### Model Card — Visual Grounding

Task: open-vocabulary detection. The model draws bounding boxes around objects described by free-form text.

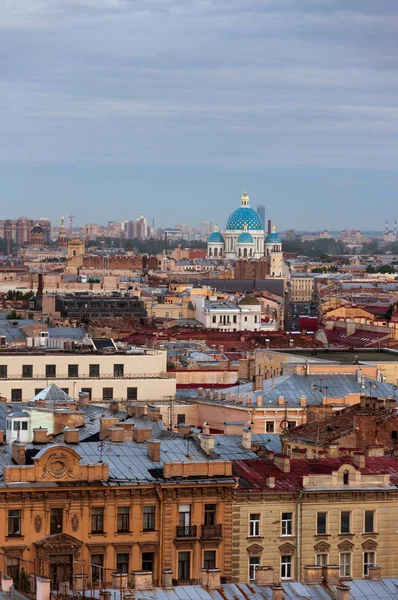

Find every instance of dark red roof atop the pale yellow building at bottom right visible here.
[233,457,398,493]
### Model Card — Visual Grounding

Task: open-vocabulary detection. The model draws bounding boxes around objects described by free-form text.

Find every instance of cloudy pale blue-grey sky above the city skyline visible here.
[0,0,398,230]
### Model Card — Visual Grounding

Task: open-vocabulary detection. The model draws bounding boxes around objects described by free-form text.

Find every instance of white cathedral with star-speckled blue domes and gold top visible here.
[207,192,283,277]
